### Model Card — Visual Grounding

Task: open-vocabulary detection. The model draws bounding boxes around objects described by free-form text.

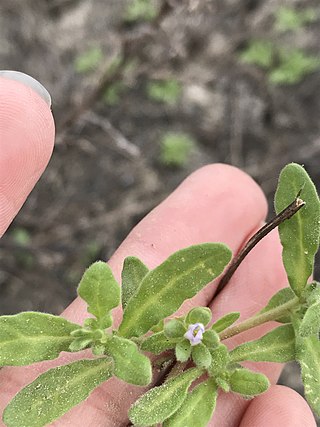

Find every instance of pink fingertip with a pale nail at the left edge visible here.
[0,71,54,237]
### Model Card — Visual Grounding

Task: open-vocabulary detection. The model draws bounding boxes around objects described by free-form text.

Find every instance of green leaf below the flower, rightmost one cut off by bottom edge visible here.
[163,378,217,427]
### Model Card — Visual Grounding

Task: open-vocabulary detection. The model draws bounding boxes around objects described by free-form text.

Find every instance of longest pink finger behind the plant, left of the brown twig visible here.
[0,165,266,427]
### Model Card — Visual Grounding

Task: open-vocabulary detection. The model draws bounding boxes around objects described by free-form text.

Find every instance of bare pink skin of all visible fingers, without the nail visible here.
[0,78,316,427]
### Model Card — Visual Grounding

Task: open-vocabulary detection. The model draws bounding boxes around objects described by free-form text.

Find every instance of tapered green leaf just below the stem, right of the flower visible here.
[230,324,295,363]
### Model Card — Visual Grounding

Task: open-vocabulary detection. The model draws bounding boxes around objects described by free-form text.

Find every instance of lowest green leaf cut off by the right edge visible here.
[295,322,320,416]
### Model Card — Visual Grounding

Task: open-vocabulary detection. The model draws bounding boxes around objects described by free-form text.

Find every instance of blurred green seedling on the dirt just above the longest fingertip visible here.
[160,132,196,168]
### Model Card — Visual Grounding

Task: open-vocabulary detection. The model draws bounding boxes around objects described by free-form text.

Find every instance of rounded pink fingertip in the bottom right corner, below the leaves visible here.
[239,385,316,427]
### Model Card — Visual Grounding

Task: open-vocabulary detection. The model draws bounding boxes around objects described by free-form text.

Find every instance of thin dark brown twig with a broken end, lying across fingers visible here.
[214,196,305,298]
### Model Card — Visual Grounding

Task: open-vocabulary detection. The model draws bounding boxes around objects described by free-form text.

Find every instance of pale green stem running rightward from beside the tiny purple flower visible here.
[219,297,300,341]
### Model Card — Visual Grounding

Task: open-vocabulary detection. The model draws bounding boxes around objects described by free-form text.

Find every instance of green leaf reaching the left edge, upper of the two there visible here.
[0,311,79,366]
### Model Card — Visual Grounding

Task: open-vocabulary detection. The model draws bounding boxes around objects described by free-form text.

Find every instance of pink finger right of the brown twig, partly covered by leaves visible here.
[211,230,287,427]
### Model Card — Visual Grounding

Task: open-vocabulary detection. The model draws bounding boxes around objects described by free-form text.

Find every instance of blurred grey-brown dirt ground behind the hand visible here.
[0,0,320,424]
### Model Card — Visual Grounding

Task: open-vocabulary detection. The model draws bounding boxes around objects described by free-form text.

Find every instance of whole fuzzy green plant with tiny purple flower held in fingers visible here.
[0,163,320,427]
